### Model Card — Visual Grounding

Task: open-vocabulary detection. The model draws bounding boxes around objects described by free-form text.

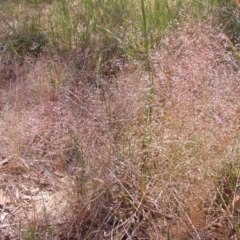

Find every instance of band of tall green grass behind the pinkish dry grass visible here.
[1,0,189,77]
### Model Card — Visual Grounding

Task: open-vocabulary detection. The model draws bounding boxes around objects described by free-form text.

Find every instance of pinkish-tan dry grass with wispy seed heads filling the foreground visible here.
[0,17,240,239]
